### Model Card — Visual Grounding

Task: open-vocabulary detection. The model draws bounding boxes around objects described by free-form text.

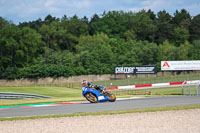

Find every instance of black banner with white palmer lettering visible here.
[115,66,156,74]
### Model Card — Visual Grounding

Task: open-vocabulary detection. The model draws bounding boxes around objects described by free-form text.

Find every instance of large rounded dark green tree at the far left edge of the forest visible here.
[0,25,43,79]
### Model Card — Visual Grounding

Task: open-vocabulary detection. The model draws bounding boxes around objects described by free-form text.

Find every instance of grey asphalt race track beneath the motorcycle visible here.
[0,96,200,118]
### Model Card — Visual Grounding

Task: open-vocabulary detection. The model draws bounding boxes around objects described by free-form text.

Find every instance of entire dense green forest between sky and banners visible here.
[0,9,200,79]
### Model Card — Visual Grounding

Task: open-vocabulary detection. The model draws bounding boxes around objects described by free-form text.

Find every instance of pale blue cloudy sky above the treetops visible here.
[0,0,200,24]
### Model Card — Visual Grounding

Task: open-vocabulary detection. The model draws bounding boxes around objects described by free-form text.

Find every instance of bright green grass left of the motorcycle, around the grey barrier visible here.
[0,86,85,106]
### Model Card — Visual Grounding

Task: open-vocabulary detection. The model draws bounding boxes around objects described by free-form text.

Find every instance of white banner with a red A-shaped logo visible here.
[161,60,200,71]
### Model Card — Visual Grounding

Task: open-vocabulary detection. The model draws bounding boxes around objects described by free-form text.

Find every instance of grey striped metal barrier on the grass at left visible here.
[0,92,51,100]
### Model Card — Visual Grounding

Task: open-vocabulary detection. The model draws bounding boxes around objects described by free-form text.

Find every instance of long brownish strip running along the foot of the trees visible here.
[0,71,200,87]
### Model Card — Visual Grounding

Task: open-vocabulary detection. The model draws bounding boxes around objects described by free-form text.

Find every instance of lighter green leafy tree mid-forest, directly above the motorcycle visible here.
[76,33,113,74]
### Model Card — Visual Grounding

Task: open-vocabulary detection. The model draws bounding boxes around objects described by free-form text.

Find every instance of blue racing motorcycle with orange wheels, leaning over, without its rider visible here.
[82,86,116,103]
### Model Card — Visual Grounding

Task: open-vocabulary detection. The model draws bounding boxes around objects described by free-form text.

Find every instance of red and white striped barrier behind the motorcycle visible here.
[107,80,200,90]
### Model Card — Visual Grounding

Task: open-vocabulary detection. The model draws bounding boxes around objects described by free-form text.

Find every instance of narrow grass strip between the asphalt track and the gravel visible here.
[0,105,200,121]
